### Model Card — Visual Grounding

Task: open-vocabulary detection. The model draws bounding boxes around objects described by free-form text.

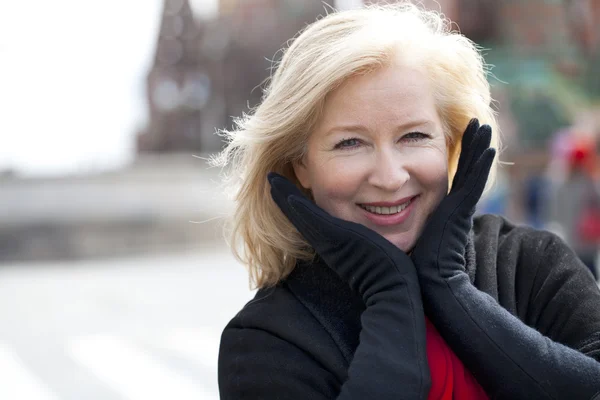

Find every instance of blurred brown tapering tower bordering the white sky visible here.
[138,0,211,151]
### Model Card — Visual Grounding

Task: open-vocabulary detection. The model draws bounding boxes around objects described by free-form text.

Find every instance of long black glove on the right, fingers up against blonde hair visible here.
[411,120,600,399]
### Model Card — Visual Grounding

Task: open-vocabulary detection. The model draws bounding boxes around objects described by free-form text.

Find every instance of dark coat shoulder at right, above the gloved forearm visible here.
[473,215,600,359]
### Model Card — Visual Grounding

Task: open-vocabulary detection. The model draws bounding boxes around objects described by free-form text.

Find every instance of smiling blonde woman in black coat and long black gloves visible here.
[215,4,600,399]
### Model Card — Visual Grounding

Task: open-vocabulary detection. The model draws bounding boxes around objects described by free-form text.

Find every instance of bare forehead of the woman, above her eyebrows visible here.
[322,65,439,130]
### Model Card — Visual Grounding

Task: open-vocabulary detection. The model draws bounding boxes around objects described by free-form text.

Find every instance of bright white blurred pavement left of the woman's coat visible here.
[0,245,253,400]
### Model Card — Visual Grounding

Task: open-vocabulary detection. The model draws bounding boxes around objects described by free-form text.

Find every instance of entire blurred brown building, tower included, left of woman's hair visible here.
[138,0,324,152]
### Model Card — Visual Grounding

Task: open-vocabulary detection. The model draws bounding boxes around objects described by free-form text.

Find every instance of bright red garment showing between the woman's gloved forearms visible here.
[425,318,488,400]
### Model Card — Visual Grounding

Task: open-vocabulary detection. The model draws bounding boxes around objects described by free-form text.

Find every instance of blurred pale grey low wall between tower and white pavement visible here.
[0,154,230,261]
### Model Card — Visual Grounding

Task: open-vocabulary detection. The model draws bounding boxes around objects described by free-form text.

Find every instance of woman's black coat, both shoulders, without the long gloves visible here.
[219,215,600,400]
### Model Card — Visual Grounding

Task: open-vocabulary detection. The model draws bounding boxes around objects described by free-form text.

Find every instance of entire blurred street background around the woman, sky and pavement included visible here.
[0,0,600,400]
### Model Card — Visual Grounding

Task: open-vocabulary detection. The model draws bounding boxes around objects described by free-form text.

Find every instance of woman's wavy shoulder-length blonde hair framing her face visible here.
[212,3,500,288]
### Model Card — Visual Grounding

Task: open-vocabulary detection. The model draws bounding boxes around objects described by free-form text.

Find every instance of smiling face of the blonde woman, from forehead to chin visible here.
[294,65,448,252]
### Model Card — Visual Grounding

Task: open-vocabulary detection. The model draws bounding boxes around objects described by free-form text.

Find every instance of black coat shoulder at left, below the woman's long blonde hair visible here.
[218,285,347,399]
